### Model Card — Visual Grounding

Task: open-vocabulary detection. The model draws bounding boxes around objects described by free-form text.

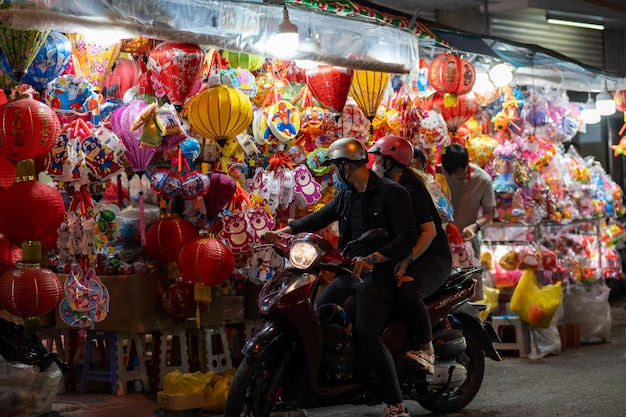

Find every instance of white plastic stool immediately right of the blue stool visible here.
[116,333,150,394]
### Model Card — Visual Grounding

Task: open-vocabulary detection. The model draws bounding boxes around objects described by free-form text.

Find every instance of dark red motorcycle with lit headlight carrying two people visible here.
[224,229,501,417]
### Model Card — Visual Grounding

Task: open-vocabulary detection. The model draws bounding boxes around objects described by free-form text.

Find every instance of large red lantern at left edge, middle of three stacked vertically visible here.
[0,159,65,245]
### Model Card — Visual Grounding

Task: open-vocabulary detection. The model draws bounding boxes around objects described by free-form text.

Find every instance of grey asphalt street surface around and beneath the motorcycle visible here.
[46,303,626,417]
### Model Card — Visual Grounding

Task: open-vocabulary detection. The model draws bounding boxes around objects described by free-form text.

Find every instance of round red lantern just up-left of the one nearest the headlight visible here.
[145,215,198,265]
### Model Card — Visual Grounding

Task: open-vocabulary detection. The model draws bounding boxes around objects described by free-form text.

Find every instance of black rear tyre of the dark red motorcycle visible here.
[417,325,485,413]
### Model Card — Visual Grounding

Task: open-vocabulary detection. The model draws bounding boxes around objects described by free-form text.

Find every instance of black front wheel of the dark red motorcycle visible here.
[224,349,287,417]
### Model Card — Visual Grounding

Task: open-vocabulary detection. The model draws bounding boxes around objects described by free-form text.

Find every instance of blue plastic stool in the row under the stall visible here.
[81,330,118,395]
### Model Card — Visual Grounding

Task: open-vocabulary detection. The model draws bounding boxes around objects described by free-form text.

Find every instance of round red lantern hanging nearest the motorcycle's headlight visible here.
[178,236,235,285]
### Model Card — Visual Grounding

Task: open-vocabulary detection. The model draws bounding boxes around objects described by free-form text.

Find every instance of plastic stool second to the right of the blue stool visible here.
[153,326,189,389]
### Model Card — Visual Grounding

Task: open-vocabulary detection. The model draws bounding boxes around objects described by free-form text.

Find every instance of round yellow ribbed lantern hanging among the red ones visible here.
[187,85,252,144]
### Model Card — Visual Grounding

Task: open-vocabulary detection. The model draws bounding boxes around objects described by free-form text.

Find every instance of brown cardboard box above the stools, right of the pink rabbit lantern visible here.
[55,273,173,333]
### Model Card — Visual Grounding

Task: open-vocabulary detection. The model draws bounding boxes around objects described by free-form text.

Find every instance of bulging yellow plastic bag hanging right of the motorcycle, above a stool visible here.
[511,269,563,328]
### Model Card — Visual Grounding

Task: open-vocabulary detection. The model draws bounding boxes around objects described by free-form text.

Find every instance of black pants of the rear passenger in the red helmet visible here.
[395,256,452,346]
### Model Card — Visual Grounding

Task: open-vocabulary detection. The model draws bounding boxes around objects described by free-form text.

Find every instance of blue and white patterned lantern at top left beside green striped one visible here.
[22,30,72,89]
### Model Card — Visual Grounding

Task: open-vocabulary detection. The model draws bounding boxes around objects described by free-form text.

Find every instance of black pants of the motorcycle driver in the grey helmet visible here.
[316,274,402,404]
